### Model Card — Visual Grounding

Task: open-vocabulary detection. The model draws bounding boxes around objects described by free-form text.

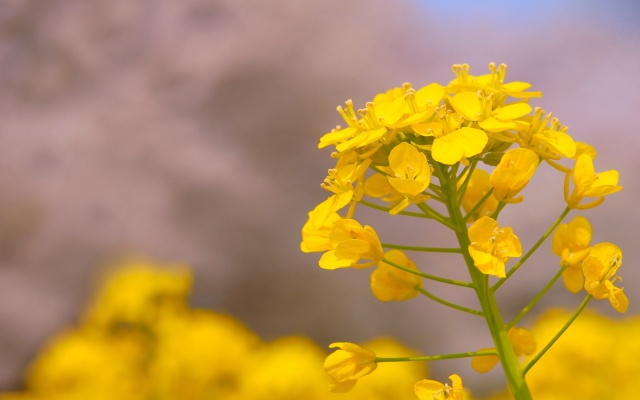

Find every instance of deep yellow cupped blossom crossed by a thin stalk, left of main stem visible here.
[371,250,422,301]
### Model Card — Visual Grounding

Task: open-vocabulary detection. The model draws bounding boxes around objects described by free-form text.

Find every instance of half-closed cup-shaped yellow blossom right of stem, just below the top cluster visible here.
[490,148,539,203]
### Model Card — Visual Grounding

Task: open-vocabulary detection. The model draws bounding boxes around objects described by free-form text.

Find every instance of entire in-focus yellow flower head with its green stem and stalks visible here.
[300,63,628,400]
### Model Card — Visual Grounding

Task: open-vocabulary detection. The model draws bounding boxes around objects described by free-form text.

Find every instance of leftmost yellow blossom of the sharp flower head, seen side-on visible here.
[300,192,353,253]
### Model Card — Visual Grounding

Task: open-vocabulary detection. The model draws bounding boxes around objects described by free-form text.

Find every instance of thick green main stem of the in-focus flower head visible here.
[434,163,533,400]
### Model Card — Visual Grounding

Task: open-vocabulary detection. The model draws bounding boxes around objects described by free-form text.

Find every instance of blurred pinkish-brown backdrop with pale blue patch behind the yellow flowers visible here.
[0,0,640,394]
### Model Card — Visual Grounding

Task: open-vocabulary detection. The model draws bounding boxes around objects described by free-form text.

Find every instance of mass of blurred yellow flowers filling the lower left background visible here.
[0,260,428,400]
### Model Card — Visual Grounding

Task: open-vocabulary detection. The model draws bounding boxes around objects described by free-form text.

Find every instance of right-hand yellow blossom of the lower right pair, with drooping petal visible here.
[582,243,629,313]
